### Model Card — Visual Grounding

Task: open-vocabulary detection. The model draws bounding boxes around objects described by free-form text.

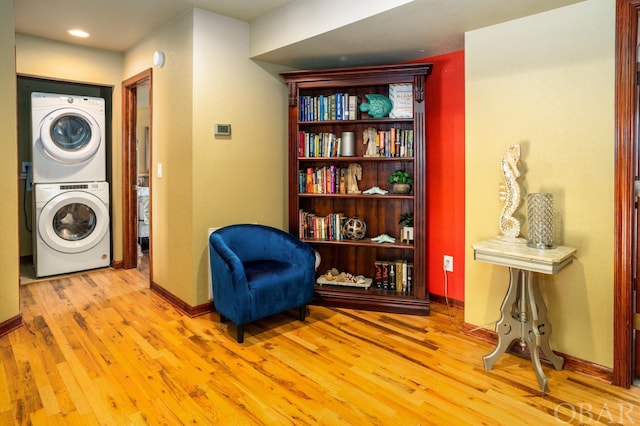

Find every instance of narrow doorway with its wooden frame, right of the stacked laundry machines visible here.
[122,69,153,282]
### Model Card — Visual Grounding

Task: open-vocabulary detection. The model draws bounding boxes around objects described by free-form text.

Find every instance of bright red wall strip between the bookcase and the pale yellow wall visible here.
[417,51,466,301]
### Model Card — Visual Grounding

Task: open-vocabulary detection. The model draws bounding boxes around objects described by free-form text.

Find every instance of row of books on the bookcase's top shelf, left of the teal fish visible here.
[298,93,358,121]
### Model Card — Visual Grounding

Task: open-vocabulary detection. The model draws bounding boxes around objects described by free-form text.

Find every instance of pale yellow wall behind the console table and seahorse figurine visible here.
[465,0,615,367]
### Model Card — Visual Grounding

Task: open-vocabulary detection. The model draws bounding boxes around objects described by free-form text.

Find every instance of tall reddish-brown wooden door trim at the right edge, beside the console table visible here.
[612,0,640,388]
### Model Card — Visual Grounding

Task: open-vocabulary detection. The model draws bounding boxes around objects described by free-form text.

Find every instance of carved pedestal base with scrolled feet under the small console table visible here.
[482,268,564,392]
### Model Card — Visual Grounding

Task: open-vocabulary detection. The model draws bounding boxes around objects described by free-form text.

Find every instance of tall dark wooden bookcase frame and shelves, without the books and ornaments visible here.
[281,64,432,315]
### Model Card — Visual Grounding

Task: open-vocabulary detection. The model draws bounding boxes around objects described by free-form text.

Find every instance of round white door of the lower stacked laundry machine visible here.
[38,191,109,253]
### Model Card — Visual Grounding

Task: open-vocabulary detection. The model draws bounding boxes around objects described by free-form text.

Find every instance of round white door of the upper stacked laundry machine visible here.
[40,108,102,164]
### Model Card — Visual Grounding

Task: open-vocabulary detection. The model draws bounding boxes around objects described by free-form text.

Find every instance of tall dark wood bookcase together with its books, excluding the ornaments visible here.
[281,64,431,315]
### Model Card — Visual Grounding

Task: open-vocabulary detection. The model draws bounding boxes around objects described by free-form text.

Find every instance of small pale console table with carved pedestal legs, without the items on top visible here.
[472,238,576,392]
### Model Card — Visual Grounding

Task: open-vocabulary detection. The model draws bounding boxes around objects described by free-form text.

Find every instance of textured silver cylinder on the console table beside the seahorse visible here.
[527,192,553,249]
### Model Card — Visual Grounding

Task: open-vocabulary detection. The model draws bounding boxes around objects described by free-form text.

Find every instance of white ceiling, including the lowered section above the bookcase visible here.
[14,0,583,69]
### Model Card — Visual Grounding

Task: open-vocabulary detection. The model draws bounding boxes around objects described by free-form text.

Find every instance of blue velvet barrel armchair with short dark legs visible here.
[209,224,315,343]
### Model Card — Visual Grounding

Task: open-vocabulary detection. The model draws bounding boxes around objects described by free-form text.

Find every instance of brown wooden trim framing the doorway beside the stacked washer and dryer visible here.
[122,68,153,272]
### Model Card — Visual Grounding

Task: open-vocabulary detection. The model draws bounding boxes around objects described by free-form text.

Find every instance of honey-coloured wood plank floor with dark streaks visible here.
[0,270,640,426]
